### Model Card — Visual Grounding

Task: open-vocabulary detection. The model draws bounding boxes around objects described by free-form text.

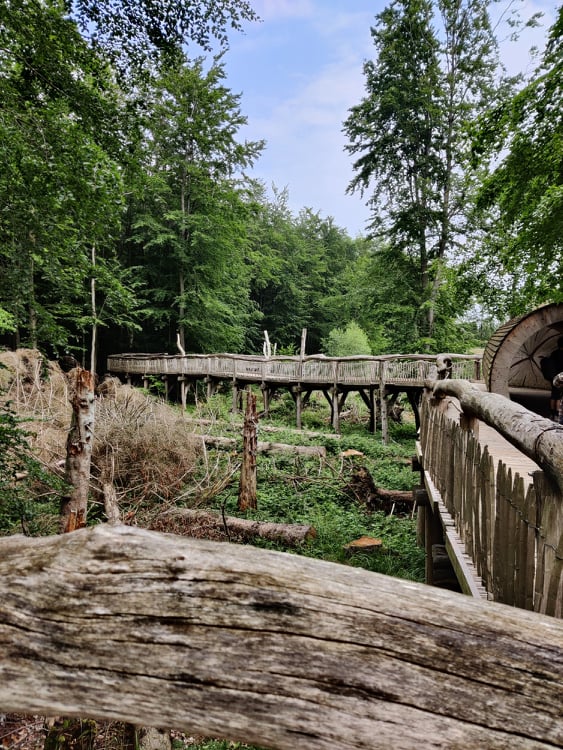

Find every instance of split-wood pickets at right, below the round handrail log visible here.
[420,399,563,617]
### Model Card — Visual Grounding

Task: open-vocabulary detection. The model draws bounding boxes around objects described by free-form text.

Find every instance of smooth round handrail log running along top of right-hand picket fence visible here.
[432,380,563,492]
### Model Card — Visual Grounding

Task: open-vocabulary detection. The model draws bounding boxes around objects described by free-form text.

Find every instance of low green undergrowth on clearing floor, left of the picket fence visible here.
[207,390,424,580]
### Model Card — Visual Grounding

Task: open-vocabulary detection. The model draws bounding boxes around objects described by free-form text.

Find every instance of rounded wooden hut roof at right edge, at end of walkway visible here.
[483,303,563,397]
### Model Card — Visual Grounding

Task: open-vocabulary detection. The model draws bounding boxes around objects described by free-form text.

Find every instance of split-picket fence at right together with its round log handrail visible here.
[420,381,563,617]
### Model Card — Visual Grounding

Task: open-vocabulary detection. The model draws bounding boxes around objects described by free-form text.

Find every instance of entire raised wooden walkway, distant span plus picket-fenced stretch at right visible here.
[108,354,563,617]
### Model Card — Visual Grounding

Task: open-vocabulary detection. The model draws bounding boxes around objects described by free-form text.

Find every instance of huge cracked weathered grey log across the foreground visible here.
[0,525,563,750]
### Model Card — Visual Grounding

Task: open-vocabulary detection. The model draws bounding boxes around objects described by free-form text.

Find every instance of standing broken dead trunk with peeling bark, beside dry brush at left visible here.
[60,367,95,533]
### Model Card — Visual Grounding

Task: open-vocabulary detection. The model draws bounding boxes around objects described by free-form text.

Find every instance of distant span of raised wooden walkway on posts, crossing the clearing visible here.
[107,354,481,440]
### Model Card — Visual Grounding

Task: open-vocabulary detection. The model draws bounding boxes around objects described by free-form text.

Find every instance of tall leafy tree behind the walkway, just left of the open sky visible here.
[133,59,262,351]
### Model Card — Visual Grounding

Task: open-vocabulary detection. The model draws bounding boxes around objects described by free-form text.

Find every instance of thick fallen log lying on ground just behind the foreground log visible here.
[152,508,317,546]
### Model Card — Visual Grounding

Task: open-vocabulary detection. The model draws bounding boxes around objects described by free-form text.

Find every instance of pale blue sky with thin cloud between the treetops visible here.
[214,0,557,237]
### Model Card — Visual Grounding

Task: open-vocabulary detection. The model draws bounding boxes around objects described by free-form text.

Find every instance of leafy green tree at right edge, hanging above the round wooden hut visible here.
[472,8,563,316]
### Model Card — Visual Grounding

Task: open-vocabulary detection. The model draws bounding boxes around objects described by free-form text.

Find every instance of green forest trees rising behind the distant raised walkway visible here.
[0,0,563,371]
